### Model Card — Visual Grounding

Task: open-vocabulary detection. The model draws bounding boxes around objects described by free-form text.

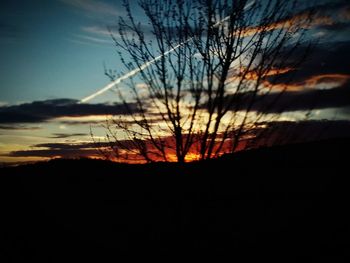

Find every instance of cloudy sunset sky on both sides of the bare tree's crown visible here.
[0,0,350,163]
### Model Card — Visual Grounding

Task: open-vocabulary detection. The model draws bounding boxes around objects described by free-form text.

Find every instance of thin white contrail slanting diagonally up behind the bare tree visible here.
[78,0,255,103]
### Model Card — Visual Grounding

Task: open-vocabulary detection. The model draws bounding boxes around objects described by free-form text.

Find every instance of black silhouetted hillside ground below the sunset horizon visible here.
[0,139,350,262]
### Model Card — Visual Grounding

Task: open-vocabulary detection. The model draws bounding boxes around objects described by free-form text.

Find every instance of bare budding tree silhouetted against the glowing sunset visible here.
[99,0,312,162]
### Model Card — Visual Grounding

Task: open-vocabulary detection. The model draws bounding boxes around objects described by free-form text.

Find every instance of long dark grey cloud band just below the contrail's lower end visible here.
[0,99,136,123]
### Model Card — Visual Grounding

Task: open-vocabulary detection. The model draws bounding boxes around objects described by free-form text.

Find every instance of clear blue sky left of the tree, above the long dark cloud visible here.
[0,0,129,104]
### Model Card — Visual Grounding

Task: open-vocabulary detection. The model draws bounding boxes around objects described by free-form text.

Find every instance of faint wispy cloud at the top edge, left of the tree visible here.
[61,0,122,16]
